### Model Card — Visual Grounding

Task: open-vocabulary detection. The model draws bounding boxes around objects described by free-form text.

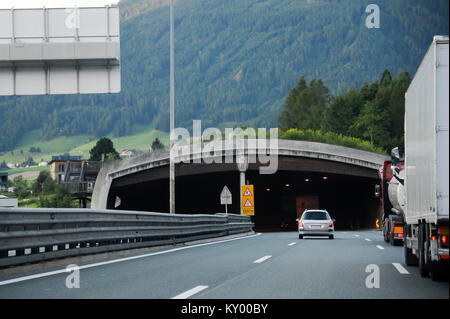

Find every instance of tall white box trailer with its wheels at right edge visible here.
[404,36,449,280]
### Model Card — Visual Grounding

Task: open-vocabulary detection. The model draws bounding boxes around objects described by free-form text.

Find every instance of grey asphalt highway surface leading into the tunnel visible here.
[0,231,449,299]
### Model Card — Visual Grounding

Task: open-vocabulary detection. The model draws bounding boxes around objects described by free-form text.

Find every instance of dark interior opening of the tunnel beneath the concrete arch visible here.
[108,168,381,231]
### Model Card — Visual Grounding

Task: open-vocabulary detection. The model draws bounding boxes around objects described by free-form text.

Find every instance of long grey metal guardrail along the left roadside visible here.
[0,208,254,267]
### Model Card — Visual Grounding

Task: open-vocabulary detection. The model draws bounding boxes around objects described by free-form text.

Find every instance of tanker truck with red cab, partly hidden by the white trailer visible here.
[375,156,405,246]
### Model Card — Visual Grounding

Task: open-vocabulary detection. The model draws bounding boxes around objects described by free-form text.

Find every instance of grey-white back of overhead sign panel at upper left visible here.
[0,0,121,96]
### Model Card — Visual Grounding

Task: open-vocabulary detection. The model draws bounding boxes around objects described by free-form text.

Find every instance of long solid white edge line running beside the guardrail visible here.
[0,233,261,286]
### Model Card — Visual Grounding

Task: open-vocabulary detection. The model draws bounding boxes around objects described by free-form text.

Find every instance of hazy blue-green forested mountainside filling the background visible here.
[0,0,449,152]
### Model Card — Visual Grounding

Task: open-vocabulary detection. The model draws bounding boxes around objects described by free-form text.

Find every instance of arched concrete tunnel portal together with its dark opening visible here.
[92,140,388,230]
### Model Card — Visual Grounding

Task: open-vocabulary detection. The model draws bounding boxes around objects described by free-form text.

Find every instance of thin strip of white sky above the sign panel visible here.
[0,0,120,9]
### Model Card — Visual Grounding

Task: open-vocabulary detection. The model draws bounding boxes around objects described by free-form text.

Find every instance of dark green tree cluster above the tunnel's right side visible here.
[278,70,411,152]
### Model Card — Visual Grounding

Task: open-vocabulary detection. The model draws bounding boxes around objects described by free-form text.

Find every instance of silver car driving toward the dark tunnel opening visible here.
[298,209,335,239]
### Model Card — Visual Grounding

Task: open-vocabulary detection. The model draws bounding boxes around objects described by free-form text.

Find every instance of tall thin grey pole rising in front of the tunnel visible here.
[169,0,175,214]
